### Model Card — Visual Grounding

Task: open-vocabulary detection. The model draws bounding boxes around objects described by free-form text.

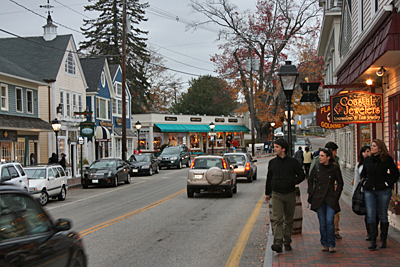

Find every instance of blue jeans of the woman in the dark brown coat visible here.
[317,200,336,247]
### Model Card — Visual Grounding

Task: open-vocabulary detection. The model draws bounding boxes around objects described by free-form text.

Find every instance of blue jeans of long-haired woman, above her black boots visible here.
[364,188,392,223]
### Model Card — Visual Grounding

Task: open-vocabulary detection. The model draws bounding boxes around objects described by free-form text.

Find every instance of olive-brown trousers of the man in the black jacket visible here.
[271,191,296,245]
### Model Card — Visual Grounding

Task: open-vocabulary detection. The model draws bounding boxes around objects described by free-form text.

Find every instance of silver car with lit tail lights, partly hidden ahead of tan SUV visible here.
[224,153,257,183]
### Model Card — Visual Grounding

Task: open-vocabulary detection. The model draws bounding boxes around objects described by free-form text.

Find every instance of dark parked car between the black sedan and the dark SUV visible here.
[128,153,160,176]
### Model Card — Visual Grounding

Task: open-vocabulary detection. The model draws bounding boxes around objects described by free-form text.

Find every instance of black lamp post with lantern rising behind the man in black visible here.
[278,61,299,156]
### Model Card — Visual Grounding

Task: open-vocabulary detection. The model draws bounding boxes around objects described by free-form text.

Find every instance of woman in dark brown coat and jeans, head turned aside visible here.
[308,148,343,252]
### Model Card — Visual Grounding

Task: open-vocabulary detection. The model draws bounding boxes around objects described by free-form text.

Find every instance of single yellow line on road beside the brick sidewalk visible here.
[225,196,264,267]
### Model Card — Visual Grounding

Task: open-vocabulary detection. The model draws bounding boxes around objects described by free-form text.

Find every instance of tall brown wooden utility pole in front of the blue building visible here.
[122,0,126,160]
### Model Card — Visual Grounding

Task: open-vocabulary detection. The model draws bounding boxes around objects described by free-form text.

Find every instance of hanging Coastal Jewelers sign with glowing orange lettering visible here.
[331,91,383,124]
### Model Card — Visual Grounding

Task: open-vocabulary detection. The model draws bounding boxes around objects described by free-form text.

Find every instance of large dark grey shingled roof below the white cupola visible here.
[0,34,72,82]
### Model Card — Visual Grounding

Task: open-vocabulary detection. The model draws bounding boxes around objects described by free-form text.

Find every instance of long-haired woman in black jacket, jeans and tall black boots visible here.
[360,139,399,250]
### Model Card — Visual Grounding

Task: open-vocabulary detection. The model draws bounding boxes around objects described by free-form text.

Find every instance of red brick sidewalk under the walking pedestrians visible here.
[264,181,400,267]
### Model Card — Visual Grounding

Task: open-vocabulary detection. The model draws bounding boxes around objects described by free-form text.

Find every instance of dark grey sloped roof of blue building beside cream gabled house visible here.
[79,57,106,92]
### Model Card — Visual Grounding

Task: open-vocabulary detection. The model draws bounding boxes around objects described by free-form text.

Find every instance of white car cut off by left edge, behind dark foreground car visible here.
[0,162,29,192]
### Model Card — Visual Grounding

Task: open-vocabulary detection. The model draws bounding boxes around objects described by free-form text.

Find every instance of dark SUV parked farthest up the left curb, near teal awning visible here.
[157,145,190,169]
